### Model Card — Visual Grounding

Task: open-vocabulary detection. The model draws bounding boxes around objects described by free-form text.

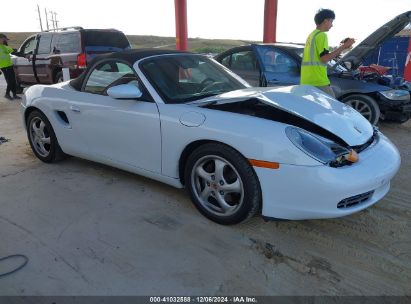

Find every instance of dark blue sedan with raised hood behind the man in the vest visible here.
[215,12,411,124]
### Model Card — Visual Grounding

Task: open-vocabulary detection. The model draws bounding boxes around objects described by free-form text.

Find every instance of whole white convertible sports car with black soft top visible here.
[22,50,400,224]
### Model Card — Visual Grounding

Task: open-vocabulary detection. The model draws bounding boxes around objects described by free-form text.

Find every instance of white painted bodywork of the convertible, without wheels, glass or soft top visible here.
[22,52,400,219]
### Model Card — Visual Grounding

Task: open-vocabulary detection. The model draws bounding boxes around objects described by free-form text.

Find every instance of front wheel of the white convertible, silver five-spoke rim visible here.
[185,143,262,225]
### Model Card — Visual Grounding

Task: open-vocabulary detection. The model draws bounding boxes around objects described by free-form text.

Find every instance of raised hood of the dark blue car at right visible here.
[333,11,411,70]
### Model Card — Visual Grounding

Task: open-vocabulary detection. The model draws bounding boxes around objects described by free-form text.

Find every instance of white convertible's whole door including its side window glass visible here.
[69,60,161,173]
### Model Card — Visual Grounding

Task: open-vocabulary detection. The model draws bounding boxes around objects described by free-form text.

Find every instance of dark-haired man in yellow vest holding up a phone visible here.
[300,9,355,97]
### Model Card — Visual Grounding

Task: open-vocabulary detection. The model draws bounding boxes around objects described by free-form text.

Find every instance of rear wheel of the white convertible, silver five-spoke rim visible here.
[26,111,65,163]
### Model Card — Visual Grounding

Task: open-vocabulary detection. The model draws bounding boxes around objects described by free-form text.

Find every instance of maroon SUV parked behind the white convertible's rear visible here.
[13,27,131,84]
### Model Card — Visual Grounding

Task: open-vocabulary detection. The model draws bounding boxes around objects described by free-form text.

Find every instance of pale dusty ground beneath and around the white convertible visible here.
[0,80,411,296]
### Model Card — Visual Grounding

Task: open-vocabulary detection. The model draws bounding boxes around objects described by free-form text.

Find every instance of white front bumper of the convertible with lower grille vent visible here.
[256,134,400,220]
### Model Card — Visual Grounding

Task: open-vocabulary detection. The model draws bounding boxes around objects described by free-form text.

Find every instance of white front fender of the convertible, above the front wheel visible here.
[158,104,320,178]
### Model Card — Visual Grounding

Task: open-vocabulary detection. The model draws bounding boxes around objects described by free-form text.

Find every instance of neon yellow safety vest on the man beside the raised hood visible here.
[300,29,330,87]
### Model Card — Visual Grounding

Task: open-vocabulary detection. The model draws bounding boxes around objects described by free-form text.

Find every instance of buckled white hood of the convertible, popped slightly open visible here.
[196,85,374,146]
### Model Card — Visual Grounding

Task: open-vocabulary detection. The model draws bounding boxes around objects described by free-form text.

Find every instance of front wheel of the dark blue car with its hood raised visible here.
[342,94,380,125]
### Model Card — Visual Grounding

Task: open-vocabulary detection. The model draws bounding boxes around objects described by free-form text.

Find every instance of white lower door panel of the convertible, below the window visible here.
[69,93,161,173]
